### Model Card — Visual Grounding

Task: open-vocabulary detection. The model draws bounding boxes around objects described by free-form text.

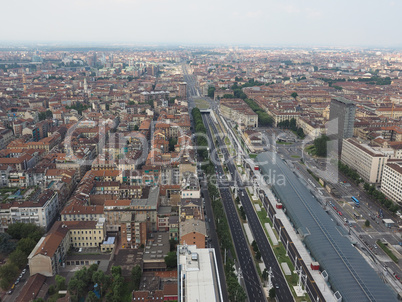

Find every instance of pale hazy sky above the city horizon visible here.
[0,0,402,47]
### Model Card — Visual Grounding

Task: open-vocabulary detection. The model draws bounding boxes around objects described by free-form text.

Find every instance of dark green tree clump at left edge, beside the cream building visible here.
[0,223,44,290]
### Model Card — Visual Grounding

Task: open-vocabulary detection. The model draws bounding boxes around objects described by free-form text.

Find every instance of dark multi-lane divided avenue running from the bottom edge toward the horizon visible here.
[183,68,294,302]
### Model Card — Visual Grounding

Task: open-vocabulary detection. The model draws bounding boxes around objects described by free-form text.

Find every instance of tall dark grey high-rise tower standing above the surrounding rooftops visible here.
[328,97,356,154]
